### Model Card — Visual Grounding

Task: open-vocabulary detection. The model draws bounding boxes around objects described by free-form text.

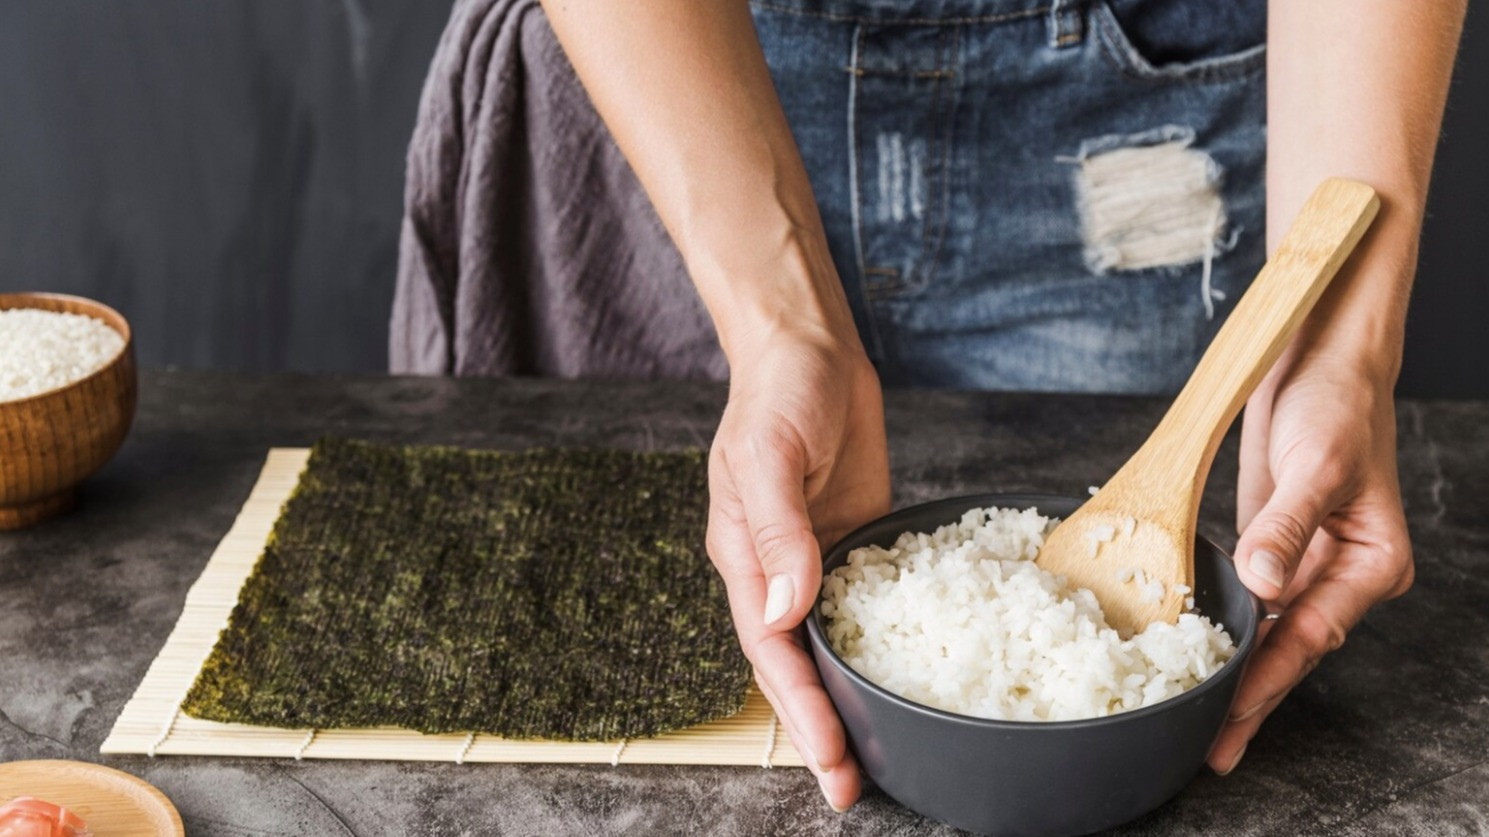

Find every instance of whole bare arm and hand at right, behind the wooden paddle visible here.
[1232,0,1467,773]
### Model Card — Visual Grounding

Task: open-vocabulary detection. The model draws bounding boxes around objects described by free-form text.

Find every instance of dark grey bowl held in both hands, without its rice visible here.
[807,494,1263,836]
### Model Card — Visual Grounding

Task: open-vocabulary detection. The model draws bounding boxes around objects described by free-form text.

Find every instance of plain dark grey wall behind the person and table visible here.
[0,0,1489,398]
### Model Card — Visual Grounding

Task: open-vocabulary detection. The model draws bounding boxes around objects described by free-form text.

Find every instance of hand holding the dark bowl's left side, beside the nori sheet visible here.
[707,329,889,812]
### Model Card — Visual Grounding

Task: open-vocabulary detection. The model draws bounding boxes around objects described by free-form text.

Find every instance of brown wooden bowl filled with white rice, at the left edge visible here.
[0,293,137,530]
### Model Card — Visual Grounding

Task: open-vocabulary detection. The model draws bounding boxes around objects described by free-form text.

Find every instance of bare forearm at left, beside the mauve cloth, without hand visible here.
[543,0,856,362]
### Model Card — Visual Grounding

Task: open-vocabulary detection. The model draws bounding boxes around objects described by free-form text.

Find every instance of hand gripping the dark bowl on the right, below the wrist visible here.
[1209,351,1412,774]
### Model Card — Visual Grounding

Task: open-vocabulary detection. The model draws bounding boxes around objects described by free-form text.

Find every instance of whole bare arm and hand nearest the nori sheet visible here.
[543,0,889,810]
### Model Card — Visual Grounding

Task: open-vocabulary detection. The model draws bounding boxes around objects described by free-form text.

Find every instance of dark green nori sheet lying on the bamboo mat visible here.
[183,438,750,740]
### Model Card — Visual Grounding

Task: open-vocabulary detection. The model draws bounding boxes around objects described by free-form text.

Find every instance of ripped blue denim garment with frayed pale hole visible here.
[753,0,1266,393]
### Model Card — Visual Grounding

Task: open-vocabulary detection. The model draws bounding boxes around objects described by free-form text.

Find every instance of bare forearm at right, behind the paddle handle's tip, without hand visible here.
[1267,0,1467,387]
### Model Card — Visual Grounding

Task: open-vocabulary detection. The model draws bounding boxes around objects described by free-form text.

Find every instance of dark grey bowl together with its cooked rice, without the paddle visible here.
[807,494,1261,836]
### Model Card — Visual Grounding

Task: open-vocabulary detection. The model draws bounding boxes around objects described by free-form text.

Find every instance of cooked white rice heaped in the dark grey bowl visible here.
[822,508,1236,721]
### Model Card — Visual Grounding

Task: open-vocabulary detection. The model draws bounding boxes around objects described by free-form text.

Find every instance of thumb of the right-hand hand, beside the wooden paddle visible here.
[1236,475,1333,600]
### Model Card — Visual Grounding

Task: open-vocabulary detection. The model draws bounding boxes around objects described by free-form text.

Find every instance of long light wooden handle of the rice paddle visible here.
[1144,177,1380,488]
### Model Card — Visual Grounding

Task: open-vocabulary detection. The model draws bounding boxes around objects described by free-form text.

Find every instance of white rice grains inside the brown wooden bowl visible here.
[0,308,124,402]
